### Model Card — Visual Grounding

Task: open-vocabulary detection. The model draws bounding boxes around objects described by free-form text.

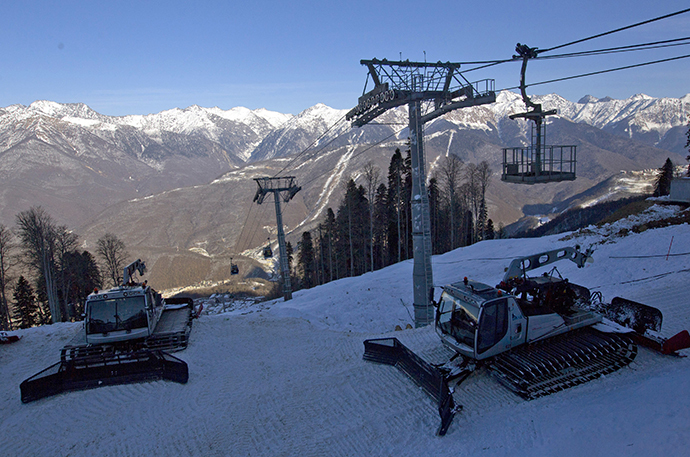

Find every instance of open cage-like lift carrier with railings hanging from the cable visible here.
[501,43,576,184]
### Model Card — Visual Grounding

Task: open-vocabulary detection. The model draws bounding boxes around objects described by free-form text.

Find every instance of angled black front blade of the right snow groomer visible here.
[363,338,455,436]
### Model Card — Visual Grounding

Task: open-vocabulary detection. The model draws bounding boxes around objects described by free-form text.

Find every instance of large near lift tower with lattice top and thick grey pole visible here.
[347,59,496,327]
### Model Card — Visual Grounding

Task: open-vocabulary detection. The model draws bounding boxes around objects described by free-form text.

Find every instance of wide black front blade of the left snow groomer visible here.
[19,351,189,403]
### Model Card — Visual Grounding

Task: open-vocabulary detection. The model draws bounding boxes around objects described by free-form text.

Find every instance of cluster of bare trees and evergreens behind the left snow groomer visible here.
[0,206,128,330]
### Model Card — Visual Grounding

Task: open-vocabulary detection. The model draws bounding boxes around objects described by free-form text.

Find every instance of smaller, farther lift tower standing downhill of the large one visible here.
[254,176,302,301]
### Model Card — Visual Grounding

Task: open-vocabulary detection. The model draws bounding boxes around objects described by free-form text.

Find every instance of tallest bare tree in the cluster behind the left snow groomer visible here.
[17,206,62,323]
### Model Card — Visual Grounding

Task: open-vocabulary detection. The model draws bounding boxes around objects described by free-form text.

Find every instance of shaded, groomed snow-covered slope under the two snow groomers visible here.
[0,207,690,457]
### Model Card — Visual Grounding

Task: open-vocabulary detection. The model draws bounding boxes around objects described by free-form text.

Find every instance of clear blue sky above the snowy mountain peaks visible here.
[0,0,690,115]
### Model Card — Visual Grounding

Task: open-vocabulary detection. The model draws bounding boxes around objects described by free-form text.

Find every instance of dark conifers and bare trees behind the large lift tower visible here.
[293,149,502,288]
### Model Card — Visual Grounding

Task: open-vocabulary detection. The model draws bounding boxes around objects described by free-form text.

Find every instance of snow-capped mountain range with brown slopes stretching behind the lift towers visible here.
[0,92,690,287]
